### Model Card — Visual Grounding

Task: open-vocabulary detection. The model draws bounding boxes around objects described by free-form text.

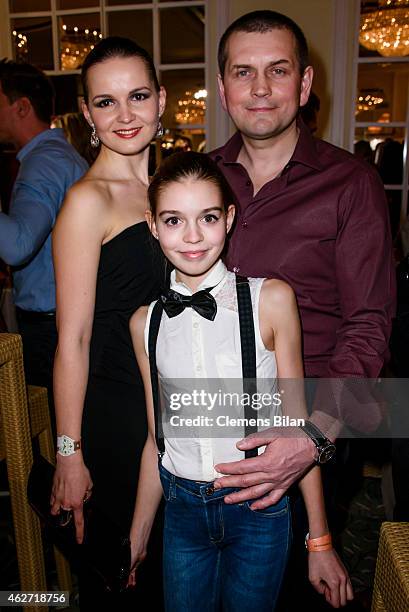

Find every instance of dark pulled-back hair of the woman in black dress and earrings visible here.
[81,36,160,102]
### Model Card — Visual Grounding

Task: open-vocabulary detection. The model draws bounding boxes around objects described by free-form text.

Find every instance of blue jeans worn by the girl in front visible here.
[159,465,291,612]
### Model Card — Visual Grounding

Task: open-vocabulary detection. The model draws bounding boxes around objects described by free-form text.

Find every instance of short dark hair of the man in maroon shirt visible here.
[217,11,309,78]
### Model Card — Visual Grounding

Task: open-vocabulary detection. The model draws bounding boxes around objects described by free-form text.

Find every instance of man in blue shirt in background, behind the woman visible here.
[0,60,88,416]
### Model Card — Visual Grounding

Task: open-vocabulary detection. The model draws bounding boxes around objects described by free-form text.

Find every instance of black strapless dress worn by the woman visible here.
[80,222,164,610]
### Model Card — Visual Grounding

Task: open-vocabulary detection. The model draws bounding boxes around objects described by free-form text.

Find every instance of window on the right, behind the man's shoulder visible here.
[350,0,409,237]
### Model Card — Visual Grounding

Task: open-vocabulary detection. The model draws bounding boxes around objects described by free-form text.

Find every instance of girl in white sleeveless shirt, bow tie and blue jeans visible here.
[130,152,352,612]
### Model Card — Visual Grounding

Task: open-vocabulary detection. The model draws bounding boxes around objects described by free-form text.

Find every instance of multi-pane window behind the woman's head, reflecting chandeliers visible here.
[9,0,208,155]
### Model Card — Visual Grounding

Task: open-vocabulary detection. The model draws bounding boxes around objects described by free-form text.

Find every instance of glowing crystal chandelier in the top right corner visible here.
[359,0,409,57]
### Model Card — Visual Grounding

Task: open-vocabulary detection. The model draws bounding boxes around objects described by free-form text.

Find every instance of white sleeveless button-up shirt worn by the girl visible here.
[145,261,277,481]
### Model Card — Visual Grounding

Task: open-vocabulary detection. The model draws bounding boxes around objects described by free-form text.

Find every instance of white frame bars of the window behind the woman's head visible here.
[7,0,209,139]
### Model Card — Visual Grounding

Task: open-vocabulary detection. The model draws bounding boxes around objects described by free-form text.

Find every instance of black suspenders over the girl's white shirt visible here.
[148,276,257,459]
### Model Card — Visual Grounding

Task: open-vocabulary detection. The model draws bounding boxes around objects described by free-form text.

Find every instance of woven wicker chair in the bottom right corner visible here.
[371,523,409,612]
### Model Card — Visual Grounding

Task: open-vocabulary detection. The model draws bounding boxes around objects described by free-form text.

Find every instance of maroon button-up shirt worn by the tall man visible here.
[211,122,395,378]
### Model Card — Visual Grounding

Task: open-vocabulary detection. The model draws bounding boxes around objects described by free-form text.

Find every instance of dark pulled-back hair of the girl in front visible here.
[148,151,236,216]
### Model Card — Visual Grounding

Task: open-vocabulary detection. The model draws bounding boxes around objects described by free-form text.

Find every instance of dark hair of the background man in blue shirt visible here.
[0,59,55,124]
